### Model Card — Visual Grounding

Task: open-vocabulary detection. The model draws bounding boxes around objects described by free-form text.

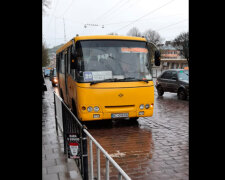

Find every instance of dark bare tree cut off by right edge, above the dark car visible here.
[172,32,189,64]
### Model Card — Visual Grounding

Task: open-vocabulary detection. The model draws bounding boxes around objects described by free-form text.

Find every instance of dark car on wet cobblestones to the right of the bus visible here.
[156,69,189,100]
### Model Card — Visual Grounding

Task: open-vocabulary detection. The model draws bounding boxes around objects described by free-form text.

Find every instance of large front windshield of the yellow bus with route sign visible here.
[76,40,152,82]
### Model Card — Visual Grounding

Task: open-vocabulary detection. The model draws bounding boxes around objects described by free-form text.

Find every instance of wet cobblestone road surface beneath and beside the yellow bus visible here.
[45,78,189,180]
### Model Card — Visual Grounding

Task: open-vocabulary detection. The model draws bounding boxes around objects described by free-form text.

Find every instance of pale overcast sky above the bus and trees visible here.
[42,0,189,48]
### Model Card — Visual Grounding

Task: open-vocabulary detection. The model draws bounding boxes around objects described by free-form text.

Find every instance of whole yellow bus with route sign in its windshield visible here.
[56,35,160,121]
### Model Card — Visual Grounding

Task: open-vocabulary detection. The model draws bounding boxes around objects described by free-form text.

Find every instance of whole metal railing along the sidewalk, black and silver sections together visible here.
[54,92,130,180]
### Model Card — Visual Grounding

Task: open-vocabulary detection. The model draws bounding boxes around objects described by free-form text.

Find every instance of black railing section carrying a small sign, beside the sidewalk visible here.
[54,92,88,180]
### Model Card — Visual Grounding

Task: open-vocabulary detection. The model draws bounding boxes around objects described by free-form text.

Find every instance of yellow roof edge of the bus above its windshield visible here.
[56,35,146,54]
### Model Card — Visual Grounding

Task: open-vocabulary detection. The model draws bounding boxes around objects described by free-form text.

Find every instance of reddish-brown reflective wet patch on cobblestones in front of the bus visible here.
[86,120,153,179]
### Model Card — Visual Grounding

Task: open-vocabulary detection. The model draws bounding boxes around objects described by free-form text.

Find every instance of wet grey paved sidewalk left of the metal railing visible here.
[42,78,82,180]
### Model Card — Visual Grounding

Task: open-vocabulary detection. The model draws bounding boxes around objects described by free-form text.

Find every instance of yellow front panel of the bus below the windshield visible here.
[75,82,154,121]
